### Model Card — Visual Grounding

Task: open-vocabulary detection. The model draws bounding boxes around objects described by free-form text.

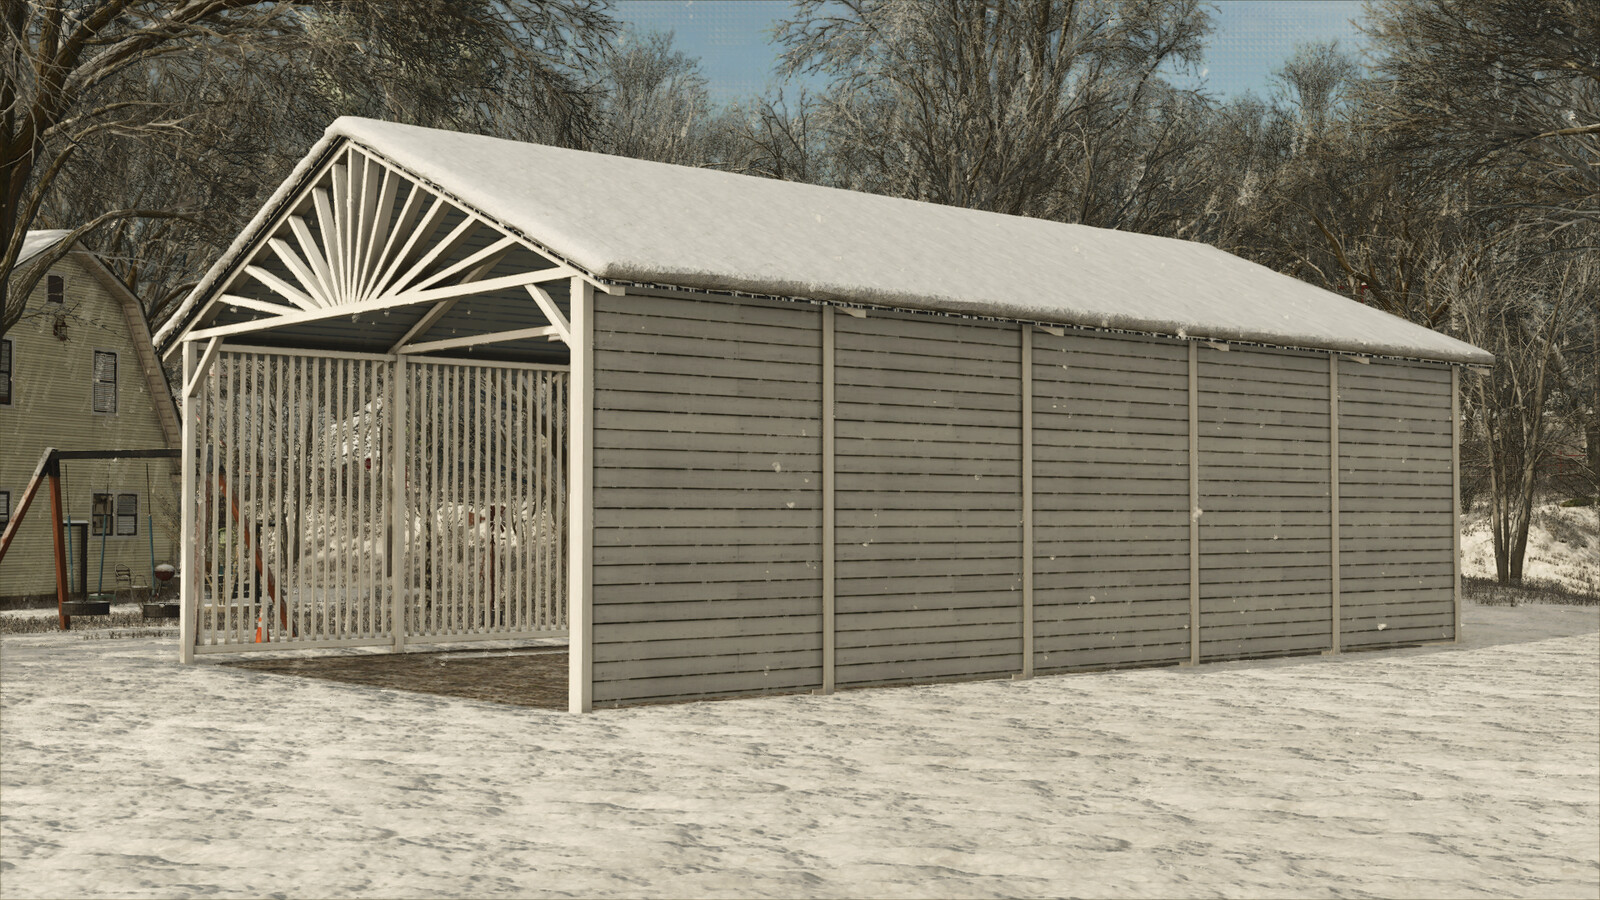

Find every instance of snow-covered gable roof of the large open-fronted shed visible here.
[157,117,1493,365]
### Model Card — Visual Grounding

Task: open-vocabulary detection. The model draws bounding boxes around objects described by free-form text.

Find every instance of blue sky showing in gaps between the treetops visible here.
[616,0,1362,101]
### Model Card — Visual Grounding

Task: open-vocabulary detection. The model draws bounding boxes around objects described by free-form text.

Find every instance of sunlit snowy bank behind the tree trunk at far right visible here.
[1461,503,1600,597]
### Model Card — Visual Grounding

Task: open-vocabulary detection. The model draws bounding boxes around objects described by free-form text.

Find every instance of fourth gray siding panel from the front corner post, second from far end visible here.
[1200,346,1333,660]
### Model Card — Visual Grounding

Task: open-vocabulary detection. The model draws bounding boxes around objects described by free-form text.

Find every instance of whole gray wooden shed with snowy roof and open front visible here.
[157,119,1491,711]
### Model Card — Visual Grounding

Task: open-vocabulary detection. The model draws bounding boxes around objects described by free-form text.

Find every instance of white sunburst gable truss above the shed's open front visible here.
[187,143,587,354]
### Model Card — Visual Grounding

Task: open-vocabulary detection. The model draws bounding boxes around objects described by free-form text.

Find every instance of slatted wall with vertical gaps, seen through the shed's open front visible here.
[186,348,568,652]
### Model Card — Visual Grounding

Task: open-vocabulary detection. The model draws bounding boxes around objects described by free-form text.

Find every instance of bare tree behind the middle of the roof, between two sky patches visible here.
[778,0,1210,226]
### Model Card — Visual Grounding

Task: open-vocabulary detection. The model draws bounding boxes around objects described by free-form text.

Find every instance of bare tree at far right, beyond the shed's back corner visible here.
[1360,0,1600,560]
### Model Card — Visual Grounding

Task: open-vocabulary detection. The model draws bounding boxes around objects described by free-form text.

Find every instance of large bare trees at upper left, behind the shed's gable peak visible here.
[0,0,614,333]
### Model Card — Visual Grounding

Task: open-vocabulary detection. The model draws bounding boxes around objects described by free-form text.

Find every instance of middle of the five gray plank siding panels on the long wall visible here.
[1034,333,1189,673]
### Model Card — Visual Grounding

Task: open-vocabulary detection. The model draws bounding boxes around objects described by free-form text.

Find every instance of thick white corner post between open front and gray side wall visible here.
[566,277,595,713]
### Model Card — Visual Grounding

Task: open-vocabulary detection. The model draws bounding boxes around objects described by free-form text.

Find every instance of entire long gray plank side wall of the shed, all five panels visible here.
[594,286,1453,705]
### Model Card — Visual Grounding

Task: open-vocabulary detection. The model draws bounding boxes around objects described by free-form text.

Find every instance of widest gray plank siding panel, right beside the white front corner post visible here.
[594,295,822,705]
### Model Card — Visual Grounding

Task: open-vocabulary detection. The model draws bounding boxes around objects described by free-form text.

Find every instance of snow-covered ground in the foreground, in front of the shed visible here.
[0,605,1600,897]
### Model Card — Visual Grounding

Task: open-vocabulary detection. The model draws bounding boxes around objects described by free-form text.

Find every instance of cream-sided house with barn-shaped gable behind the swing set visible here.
[0,231,179,605]
